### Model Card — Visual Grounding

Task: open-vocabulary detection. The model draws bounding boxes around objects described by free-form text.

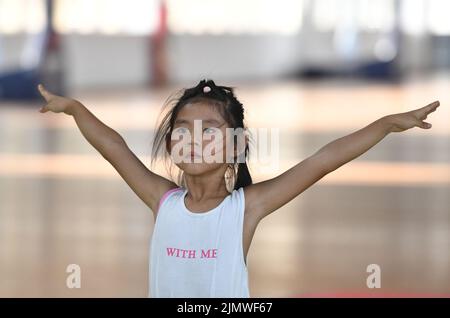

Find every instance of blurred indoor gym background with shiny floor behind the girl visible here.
[0,0,450,297]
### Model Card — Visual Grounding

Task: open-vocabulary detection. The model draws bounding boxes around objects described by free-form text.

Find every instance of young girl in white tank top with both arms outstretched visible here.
[38,80,439,297]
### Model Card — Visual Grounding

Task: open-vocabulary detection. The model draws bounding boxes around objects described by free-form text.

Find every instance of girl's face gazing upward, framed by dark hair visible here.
[170,103,233,175]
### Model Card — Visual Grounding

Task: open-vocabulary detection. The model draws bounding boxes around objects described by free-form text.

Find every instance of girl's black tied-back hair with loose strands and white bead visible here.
[151,79,253,190]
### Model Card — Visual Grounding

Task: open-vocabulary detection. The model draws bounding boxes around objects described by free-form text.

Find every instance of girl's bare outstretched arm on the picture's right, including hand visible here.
[244,102,439,222]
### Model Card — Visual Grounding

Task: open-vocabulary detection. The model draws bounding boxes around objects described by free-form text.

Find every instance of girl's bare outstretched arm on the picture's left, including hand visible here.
[38,85,176,217]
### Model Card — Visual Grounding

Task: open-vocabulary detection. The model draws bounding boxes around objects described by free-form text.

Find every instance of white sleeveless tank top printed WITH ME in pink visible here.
[149,187,250,298]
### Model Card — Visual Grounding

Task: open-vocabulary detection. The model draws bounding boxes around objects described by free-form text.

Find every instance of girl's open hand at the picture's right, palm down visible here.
[387,101,439,132]
